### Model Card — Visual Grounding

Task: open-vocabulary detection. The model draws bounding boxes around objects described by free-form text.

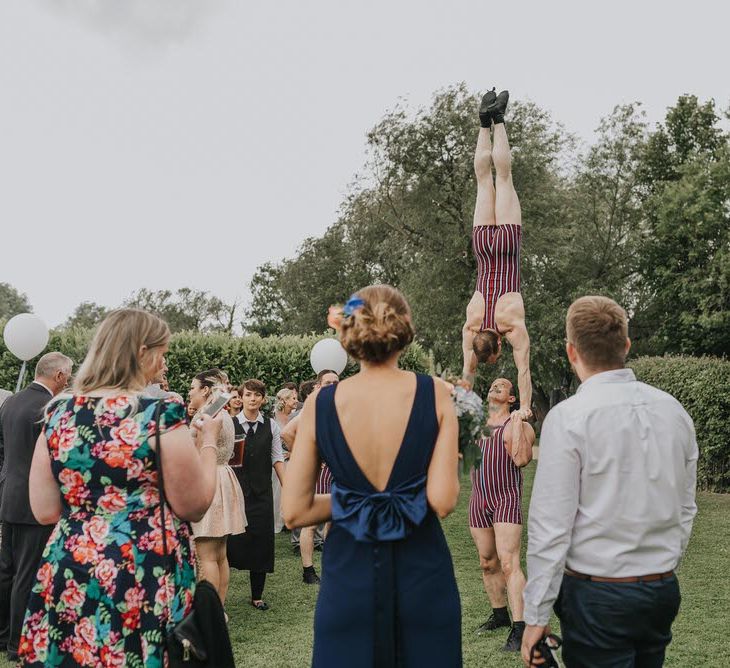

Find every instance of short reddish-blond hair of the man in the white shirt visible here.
[565,296,629,370]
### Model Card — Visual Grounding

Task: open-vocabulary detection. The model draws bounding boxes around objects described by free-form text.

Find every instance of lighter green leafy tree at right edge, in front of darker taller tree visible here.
[642,145,730,355]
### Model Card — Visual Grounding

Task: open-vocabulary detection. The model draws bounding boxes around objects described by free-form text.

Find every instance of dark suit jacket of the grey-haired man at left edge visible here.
[0,383,52,524]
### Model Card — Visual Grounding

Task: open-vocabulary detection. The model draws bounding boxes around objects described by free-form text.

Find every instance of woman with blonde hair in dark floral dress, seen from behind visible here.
[19,309,220,668]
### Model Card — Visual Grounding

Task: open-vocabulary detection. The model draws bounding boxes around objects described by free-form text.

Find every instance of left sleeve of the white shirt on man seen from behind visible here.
[524,409,580,626]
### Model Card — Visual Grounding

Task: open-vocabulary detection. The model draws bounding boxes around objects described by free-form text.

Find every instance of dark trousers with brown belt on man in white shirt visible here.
[555,575,681,668]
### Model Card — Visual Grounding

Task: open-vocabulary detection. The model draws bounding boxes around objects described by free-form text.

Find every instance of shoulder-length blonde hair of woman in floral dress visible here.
[73,308,170,394]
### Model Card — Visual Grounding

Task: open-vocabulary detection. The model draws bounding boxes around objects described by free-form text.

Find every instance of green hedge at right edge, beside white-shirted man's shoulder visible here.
[629,356,730,492]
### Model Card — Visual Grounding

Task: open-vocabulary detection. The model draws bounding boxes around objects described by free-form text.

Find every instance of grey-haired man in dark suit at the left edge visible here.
[0,353,73,661]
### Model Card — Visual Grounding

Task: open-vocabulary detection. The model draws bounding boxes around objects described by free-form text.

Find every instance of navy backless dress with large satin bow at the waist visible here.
[312,374,461,668]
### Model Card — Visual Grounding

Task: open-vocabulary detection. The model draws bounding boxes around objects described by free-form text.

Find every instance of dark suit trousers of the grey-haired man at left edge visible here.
[0,522,53,652]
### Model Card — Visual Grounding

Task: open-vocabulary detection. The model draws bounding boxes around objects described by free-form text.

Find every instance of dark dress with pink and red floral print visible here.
[19,395,195,668]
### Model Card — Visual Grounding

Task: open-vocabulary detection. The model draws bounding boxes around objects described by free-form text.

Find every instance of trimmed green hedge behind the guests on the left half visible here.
[0,329,429,396]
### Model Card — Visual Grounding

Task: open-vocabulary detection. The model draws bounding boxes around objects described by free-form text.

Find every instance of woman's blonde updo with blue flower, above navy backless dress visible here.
[340,285,415,364]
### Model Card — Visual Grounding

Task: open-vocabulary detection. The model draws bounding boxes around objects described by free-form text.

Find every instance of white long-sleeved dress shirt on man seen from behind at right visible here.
[524,369,698,626]
